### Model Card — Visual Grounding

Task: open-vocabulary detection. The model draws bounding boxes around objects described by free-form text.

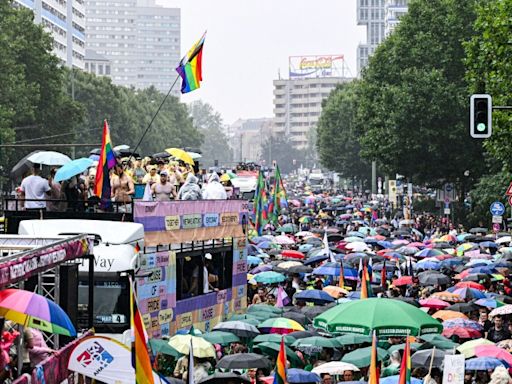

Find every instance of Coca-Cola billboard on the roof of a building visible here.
[288,55,346,79]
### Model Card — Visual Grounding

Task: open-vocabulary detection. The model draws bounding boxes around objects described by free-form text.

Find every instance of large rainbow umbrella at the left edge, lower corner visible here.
[0,289,76,336]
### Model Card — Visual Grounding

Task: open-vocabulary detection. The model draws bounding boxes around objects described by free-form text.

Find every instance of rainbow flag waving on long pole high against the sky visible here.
[176,32,206,93]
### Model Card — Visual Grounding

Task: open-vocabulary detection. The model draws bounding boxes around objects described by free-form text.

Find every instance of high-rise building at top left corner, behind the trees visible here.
[14,0,85,69]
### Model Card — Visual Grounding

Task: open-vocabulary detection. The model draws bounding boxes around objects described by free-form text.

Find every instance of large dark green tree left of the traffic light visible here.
[356,0,484,185]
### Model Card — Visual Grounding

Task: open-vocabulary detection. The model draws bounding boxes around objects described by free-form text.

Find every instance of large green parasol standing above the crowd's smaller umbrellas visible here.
[313,298,443,337]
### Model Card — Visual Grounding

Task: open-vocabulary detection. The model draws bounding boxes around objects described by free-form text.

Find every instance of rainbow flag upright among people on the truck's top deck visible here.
[94,120,116,208]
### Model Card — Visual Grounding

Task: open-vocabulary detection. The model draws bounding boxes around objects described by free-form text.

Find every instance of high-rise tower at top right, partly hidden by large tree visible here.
[357,0,386,74]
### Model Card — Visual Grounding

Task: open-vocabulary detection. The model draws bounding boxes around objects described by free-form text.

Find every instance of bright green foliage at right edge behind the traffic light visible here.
[465,0,512,172]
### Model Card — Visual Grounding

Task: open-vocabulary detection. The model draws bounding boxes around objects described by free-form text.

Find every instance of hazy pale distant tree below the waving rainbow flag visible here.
[189,101,233,166]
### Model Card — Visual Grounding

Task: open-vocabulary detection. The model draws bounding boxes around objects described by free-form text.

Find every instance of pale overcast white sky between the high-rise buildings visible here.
[156,0,366,124]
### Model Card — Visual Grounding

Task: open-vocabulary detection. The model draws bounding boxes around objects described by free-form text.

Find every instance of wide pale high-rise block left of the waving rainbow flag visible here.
[86,0,181,96]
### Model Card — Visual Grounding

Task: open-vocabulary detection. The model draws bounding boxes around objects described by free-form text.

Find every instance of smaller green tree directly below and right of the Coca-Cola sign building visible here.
[316,82,370,179]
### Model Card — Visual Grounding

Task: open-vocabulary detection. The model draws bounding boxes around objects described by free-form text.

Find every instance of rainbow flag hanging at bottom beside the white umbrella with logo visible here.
[130,278,155,384]
